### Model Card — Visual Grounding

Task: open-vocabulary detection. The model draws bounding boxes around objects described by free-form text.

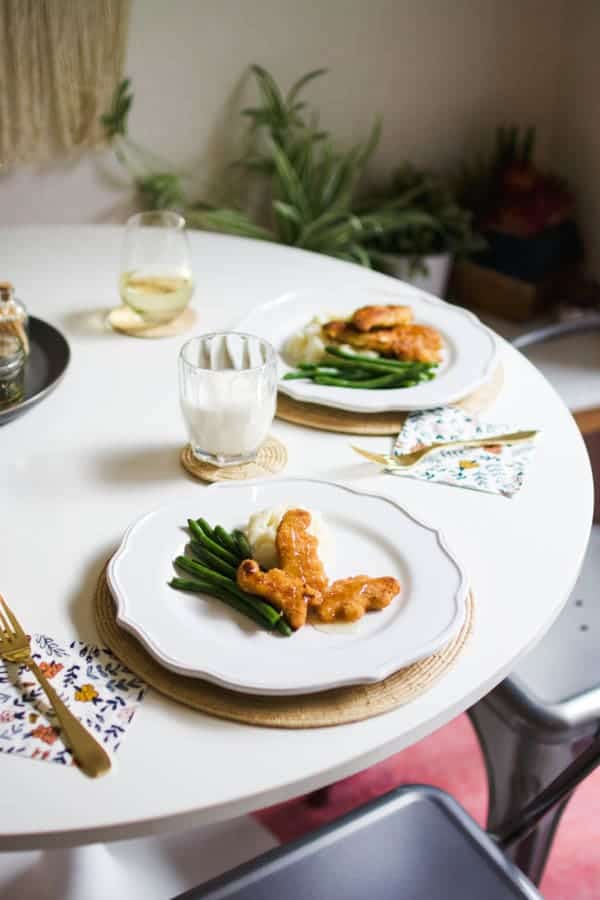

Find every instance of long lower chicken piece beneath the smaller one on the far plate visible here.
[323,319,442,363]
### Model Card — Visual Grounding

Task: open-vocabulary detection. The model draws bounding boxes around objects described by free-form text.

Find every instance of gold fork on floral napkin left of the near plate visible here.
[0,594,110,778]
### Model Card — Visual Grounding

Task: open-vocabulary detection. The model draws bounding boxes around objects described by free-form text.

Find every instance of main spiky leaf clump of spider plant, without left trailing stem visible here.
[187,66,432,266]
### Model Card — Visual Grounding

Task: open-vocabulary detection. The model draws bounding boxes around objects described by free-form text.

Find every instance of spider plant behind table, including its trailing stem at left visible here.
[103,65,430,266]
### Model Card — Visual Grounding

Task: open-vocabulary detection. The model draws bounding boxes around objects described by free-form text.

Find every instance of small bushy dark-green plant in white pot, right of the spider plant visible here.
[369,163,485,297]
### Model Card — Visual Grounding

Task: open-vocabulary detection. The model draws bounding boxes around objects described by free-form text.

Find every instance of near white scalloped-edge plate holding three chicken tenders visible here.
[108,478,474,694]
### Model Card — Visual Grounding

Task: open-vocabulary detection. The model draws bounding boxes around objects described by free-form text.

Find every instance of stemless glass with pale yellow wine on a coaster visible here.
[120,209,194,325]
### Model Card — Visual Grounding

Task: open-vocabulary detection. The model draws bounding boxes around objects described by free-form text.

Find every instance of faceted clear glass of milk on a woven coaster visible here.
[179,331,277,466]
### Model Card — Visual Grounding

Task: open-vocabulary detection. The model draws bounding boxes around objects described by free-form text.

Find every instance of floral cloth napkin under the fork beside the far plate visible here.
[388,406,535,497]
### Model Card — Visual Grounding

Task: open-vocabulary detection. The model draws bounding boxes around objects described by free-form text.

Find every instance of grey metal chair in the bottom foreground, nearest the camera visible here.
[179,738,600,900]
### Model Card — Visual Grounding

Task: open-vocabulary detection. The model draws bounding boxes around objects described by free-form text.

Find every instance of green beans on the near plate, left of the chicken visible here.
[169,519,292,637]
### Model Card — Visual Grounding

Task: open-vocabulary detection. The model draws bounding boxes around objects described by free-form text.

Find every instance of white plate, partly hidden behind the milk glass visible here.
[236,282,498,413]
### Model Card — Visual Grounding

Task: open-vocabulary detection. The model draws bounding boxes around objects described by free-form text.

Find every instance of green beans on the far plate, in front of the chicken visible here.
[283,345,437,390]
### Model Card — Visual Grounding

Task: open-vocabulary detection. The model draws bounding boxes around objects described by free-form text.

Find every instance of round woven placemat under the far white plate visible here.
[277,365,504,435]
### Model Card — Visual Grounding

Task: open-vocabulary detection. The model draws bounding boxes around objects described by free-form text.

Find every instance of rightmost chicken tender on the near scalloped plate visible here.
[315,575,400,622]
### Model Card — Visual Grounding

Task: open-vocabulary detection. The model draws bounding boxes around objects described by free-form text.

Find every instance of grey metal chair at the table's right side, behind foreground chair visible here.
[469,313,600,884]
